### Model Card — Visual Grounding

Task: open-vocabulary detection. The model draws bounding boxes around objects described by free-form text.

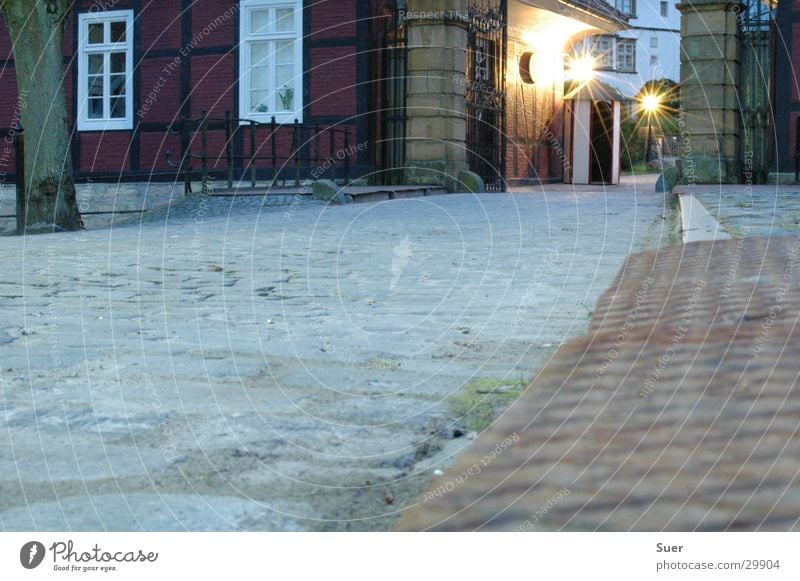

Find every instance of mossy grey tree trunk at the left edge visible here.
[0,0,83,231]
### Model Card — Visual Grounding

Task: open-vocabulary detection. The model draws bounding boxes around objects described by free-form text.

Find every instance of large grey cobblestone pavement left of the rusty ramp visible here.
[0,174,673,530]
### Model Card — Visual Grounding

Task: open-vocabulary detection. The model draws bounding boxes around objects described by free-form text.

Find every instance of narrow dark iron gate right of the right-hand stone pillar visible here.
[739,0,775,184]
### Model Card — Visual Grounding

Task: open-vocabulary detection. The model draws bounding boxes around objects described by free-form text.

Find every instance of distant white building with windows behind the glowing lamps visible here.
[575,0,681,97]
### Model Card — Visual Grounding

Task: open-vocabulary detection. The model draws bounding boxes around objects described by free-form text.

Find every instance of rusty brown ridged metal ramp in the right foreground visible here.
[398,238,800,531]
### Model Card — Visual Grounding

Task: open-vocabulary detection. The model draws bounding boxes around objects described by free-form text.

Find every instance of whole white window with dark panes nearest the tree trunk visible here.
[78,10,133,131]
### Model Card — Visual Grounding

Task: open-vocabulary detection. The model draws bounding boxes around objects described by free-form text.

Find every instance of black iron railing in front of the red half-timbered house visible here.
[166,111,359,194]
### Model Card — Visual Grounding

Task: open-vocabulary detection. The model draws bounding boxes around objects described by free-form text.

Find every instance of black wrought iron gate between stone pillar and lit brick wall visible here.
[466,0,508,191]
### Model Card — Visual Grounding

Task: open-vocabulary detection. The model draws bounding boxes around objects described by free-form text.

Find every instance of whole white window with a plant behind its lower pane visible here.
[239,0,303,123]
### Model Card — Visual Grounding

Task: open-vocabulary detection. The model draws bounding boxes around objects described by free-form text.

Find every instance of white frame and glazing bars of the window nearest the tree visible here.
[77,10,134,131]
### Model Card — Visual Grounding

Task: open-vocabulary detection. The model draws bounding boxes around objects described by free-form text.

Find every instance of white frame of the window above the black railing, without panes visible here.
[239,0,304,123]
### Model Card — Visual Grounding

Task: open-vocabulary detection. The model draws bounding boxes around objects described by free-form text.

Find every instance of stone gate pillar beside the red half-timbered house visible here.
[405,0,467,188]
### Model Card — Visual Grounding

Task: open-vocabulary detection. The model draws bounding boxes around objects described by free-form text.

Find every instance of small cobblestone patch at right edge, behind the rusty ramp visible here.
[692,185,800,238]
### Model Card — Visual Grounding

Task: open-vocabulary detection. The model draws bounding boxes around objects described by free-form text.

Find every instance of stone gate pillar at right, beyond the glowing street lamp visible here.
[678,0,742,184]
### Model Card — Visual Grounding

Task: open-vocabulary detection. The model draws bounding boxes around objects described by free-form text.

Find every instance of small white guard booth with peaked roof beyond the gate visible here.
[564,81,623,185]
